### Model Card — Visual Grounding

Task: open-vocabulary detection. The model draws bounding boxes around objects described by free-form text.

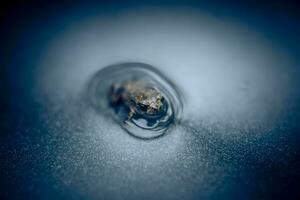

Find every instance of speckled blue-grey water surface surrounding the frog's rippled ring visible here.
[0,1,300,200]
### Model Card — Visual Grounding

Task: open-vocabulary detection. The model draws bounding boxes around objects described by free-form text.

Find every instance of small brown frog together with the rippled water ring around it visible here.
[88,63,183,139]
